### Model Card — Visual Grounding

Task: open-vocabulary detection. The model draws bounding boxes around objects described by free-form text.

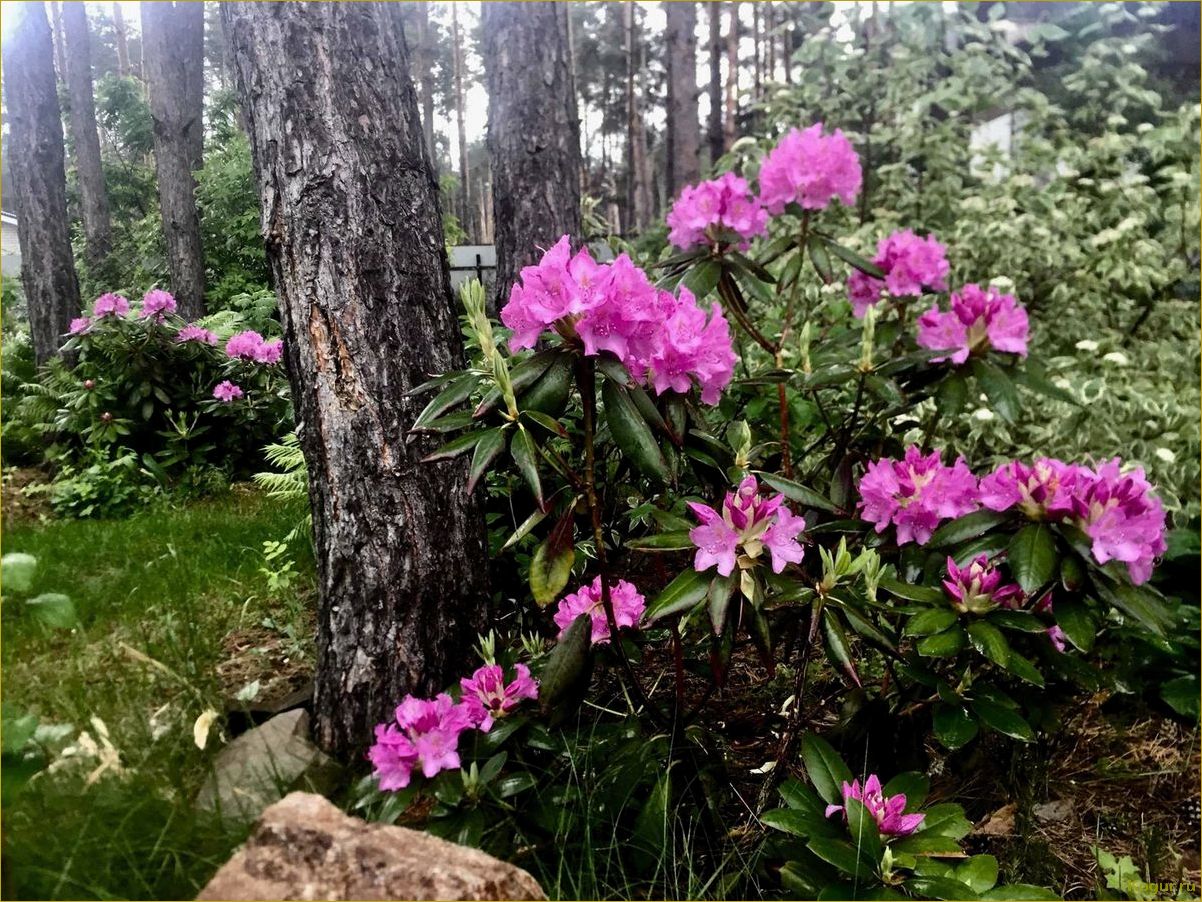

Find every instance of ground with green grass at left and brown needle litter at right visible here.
[2,486,1200,898]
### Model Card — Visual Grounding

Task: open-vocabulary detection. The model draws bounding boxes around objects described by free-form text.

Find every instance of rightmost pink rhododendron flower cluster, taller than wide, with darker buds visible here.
[1072,457,1168,586]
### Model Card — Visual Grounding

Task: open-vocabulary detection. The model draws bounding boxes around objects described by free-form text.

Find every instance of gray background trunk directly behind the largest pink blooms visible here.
[481,2,581,305]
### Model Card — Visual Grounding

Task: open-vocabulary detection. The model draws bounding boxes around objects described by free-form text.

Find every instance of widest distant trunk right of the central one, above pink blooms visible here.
[664,2,701,197]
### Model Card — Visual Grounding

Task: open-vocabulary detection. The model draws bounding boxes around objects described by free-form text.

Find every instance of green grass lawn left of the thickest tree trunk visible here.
[0,492,313,898]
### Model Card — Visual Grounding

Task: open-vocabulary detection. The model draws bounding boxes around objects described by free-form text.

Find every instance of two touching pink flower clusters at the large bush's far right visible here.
[981,457,1167,586]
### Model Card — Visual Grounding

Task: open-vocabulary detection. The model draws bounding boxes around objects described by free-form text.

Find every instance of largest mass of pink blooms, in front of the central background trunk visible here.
[501,235,736,404]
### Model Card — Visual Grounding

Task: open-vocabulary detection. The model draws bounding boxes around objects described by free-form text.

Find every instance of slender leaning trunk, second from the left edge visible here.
[63,0,113,273]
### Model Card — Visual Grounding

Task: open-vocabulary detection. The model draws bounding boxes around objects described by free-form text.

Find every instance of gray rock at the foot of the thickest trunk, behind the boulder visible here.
[196,708,339,824]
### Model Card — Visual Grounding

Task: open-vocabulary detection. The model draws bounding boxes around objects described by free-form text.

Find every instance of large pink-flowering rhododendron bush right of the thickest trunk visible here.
[363,104,1192,897]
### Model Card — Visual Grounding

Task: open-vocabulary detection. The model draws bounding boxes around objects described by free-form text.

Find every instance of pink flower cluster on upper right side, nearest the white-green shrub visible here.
[917,284,1029,364]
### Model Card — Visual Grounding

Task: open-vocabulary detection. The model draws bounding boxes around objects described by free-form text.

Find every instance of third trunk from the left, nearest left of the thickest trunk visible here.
[142,0,204,319]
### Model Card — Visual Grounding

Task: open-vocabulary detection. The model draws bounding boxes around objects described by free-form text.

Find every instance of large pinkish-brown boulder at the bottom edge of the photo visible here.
[197,793,546,900]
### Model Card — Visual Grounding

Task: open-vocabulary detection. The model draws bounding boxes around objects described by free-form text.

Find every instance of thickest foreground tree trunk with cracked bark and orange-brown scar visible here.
[221,2,488,755]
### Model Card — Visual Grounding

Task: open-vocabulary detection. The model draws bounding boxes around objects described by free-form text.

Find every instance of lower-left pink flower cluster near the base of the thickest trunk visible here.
[368,693,472,790]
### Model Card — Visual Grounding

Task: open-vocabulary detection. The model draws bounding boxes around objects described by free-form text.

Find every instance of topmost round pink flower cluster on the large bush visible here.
[760,123,863,215]
